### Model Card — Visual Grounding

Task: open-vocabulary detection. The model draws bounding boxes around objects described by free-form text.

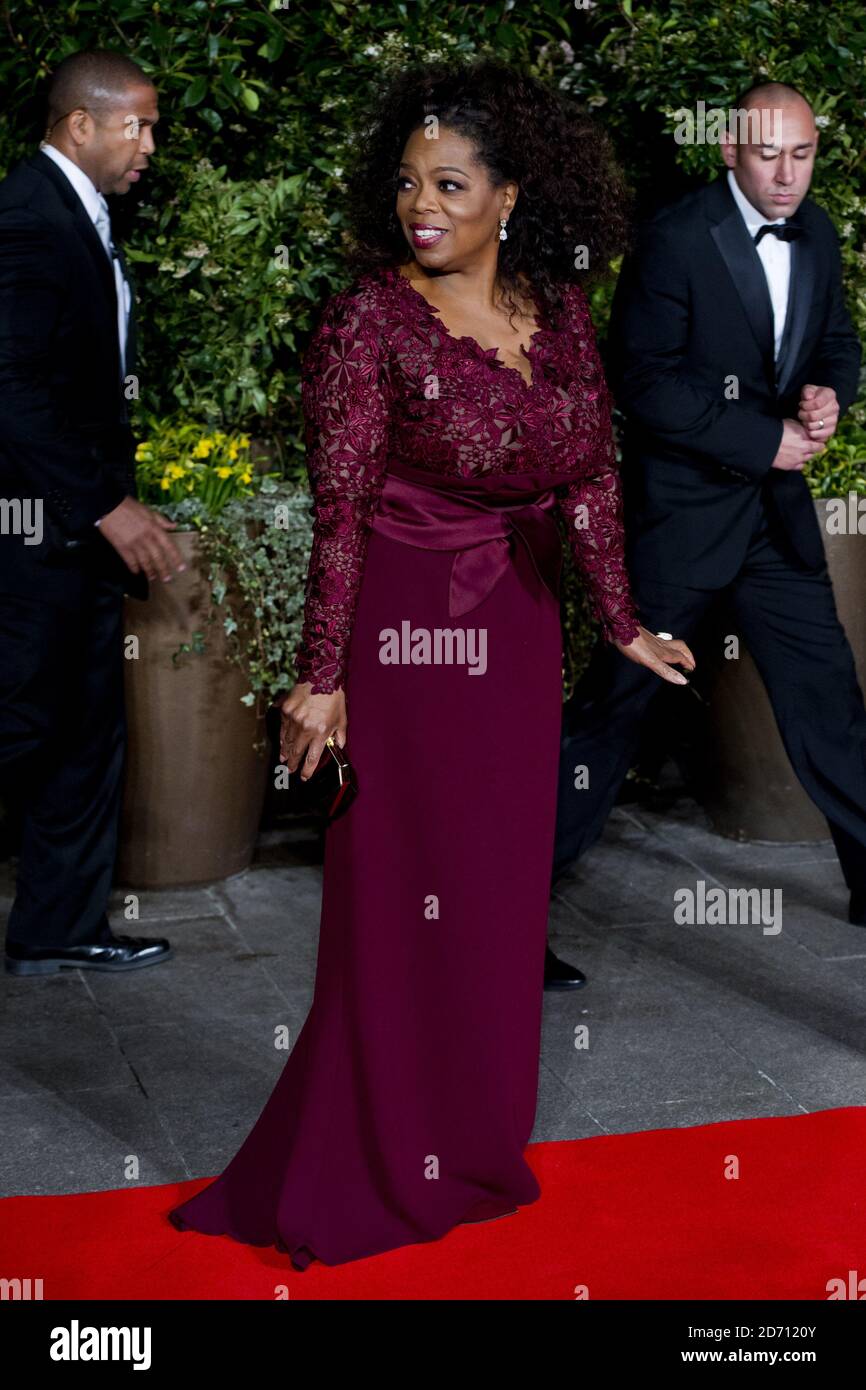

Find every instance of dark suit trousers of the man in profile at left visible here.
[0,571,126,947]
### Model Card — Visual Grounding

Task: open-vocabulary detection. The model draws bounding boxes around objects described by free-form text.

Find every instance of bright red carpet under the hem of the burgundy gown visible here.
[0,1106,866,1300]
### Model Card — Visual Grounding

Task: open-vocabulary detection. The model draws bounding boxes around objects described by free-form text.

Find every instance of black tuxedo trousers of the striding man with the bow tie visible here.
[553,505,866,905]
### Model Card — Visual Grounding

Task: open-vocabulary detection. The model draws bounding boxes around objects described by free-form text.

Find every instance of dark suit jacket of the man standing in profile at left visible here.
[0,152,147,598]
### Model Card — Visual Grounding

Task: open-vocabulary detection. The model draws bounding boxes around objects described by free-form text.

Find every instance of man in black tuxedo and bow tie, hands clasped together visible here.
[553,83,866,926]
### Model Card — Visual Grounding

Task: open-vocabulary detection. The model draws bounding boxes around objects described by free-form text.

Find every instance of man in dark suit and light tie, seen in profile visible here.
[0,51,183,974]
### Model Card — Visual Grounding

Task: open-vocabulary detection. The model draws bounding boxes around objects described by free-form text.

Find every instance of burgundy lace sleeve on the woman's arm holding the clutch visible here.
[295,293,391,694]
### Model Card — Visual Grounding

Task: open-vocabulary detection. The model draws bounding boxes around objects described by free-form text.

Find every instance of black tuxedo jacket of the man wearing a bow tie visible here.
[609,175,860,589]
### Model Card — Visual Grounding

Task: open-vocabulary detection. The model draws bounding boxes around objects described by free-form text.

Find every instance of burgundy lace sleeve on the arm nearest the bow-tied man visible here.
[559,285,638,642]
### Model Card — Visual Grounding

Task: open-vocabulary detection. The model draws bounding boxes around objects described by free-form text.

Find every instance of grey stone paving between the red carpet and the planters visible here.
[0,799,866,1195]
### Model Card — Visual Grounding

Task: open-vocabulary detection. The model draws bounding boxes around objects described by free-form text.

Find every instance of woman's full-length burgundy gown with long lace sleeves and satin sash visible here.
[170,267,638,1269]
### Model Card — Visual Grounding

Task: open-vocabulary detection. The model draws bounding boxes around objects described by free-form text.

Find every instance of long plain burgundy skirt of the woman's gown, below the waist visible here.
[170,478,562,1269]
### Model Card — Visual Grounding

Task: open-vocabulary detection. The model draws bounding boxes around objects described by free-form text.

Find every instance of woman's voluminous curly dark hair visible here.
[346,57,632,328]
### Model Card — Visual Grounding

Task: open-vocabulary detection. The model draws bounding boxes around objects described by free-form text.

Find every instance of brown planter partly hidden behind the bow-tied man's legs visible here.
[701,499,866,842]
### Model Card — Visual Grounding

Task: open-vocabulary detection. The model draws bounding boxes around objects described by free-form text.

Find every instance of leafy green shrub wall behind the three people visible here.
[0,0,866,695]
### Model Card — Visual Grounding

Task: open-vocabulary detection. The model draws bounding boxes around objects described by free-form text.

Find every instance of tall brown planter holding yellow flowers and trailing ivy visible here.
[117,531,267,888]
